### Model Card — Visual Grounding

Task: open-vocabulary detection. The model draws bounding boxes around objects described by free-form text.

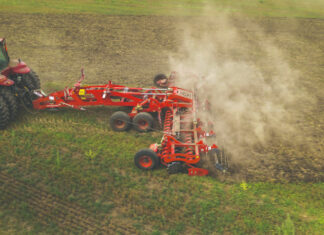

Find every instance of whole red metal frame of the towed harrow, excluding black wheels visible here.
[33,71,218,175]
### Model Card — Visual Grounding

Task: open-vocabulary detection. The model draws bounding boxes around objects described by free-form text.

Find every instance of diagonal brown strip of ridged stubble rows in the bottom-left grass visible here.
[0,172,136,234]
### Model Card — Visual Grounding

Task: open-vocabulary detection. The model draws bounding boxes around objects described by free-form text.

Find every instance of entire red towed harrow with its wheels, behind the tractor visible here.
[33,70,227,175]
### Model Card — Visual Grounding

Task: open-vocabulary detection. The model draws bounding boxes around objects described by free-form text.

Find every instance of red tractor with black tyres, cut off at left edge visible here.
[0,38,40,129]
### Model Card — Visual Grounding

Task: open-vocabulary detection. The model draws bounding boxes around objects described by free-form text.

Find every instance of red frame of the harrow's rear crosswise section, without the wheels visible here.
[150,94,218,176]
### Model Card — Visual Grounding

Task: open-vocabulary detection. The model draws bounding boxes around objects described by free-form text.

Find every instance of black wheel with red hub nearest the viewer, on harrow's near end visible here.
[134,149,160,170]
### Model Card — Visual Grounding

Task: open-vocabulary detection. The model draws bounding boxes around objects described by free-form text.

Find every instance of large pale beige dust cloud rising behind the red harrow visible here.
[169,14,307,160]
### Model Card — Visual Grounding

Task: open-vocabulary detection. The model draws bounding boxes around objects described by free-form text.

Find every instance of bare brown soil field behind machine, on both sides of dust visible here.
[0,14,324,182]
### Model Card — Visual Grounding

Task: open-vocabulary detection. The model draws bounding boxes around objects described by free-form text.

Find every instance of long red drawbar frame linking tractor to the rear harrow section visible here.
[33,70,192,117]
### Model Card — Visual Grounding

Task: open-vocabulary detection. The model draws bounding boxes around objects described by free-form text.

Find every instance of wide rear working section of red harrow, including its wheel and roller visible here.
[134,85,228,176]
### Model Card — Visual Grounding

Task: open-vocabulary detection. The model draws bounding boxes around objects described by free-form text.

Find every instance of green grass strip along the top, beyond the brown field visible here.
[0,0,324,18]
